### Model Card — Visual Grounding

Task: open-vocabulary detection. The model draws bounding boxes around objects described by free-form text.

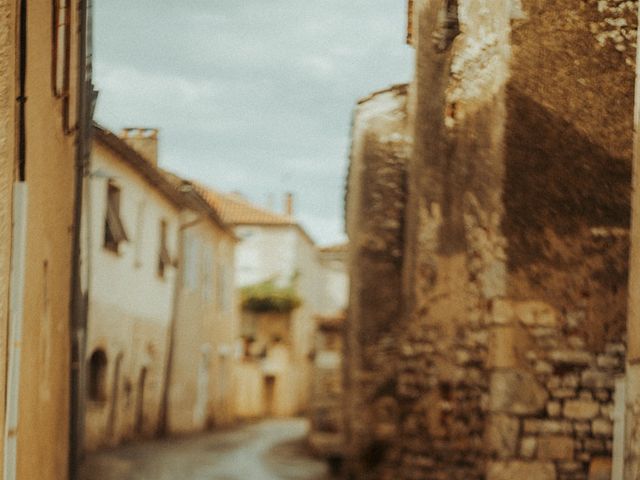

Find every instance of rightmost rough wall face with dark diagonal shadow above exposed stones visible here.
[487,1,637,480]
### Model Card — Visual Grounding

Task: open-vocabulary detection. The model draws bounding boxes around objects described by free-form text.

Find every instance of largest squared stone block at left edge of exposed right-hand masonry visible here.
[490,370,549,415]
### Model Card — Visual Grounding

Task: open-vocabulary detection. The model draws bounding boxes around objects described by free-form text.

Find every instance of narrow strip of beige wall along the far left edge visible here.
[0,0,16,468]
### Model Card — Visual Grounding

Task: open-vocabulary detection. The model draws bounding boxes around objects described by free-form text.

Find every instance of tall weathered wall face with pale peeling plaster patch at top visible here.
[397,1,510,480]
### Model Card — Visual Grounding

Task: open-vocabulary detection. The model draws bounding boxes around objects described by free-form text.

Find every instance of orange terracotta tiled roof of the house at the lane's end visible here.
[192,182,315,246]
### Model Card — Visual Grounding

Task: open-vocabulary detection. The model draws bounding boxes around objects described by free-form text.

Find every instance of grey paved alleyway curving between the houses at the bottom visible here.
[81,419,331,480]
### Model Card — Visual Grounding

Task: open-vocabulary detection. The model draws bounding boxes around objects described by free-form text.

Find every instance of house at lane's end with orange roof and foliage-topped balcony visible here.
[201,189,323,418]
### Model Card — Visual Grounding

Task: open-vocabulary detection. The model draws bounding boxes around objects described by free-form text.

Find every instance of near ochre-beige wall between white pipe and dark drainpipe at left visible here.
[16,2,85,480]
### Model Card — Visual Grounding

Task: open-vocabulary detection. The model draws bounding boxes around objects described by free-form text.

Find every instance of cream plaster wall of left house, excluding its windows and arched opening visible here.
[85,141,180,450]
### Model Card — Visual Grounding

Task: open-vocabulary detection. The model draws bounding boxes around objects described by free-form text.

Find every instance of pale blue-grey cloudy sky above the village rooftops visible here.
[94,0,412,244]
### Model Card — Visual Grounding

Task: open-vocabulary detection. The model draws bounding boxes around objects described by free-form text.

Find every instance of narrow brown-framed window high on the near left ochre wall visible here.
[51,0,71,132]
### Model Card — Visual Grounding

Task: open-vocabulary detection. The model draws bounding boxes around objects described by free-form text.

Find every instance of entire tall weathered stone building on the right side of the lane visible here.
[347,0,637,480]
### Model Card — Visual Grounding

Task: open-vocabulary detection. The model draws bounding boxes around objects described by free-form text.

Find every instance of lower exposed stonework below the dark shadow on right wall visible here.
[486,229,628,480]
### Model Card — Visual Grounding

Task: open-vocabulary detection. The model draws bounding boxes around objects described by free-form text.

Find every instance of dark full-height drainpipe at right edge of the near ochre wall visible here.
[68,0,97,480]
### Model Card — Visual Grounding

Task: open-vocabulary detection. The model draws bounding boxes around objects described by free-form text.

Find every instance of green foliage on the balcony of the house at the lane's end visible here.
[240,279,302,313]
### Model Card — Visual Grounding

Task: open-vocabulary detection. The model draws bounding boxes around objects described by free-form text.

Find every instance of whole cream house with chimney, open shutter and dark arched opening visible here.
[84,127,184,451]
